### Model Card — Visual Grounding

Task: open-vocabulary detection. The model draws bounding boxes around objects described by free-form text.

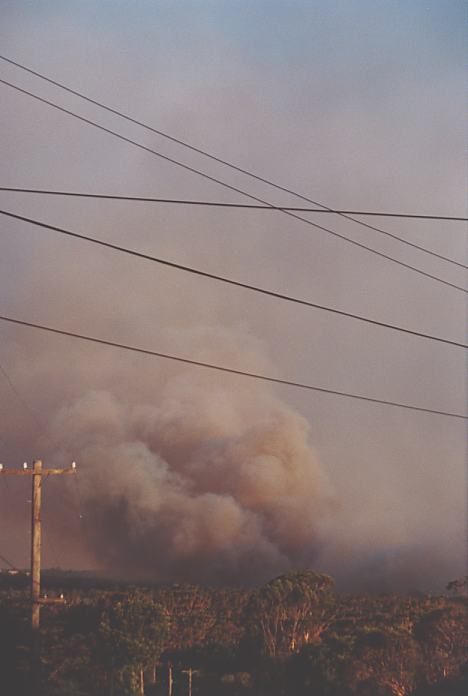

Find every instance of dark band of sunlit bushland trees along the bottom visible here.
[0,571,468,696]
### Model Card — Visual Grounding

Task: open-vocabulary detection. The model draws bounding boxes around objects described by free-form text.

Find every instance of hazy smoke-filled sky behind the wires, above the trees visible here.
[0,0,466,590]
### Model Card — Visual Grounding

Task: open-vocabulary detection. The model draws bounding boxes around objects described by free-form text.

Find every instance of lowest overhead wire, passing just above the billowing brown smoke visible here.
[0,315,468,420]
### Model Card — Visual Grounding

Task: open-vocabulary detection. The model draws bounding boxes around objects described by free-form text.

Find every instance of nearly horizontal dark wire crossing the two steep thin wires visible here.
[0,186,468,223]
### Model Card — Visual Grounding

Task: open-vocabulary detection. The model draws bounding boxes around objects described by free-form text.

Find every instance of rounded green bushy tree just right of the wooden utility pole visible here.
[99,596,167,694]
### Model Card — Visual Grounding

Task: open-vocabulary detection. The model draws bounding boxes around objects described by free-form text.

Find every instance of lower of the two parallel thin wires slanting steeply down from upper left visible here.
[0,79,468,293]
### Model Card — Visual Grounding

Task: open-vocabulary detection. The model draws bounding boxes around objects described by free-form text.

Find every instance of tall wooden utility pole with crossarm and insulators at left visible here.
[0,459,76,694]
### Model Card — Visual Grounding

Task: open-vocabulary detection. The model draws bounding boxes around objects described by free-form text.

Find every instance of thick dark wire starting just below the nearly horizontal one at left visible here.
[0,205,468,348]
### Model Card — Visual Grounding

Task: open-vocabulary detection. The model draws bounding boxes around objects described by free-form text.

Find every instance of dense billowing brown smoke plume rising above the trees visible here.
[44,330,331,582]
